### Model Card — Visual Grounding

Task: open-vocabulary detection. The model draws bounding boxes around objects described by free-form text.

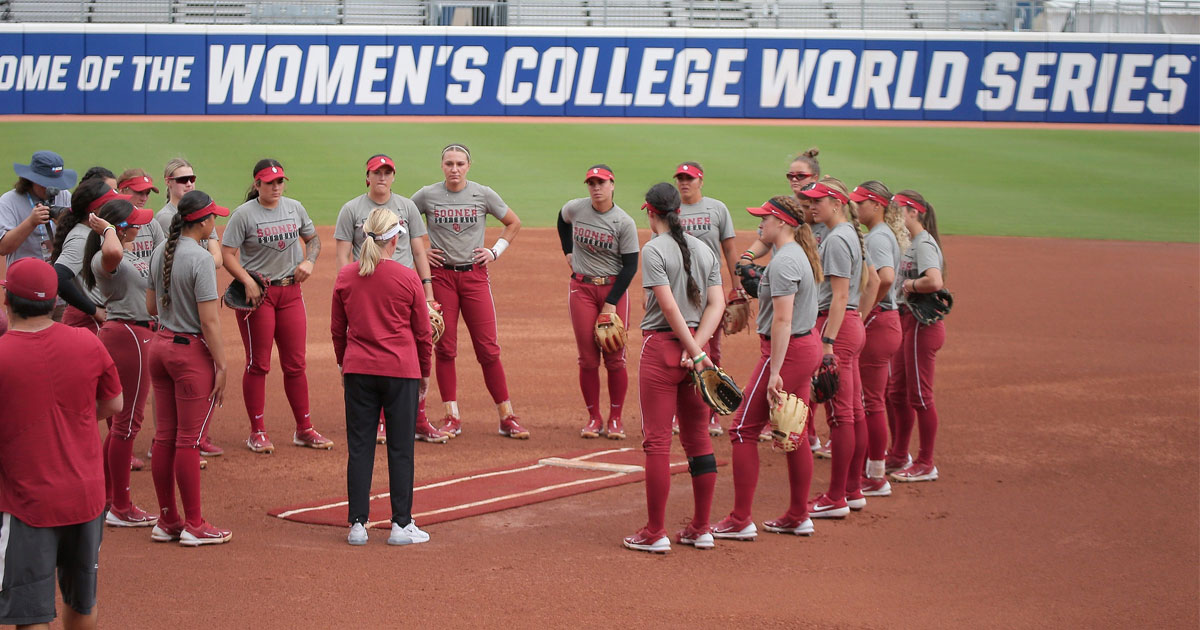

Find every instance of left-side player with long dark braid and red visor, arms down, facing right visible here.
[146,191,233,547]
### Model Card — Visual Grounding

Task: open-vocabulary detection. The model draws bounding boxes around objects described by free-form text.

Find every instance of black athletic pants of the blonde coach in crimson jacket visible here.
[342,374,420,526]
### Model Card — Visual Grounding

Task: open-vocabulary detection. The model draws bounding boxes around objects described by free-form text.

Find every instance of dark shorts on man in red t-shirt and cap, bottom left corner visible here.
[0,512,104,625]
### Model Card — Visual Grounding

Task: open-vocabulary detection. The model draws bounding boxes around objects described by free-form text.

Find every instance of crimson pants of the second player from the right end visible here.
[858,308,901,460]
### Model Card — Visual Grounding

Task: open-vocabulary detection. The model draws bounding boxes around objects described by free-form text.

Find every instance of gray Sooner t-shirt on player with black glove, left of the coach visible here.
[220,197,317,280]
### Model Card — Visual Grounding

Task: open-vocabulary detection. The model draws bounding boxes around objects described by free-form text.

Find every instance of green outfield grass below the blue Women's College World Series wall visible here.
[0,119,1200,242]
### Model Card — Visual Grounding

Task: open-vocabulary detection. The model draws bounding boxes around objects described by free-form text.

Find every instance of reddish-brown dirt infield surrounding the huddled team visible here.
[88,227,1200,630]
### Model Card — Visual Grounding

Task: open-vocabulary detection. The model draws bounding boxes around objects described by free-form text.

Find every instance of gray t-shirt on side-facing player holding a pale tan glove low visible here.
[757,241,817,335]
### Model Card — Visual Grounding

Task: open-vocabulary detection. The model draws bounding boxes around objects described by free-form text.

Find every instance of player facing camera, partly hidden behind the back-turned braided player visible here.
[674,162,746,436]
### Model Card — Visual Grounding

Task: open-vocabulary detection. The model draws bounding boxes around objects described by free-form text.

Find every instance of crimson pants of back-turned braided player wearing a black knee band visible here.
[637,330,716,534]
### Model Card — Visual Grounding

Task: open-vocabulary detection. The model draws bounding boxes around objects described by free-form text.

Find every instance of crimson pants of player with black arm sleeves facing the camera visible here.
[566,277,629,419]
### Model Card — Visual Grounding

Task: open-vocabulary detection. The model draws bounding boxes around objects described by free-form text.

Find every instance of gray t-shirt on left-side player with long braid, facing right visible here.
[150,236,218,335]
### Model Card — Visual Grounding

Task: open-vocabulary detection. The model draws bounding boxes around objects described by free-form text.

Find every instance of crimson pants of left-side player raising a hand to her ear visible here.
[98,319,155,510]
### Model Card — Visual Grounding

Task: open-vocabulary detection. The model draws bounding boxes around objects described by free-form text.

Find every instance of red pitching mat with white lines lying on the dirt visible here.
[268,448,725,527]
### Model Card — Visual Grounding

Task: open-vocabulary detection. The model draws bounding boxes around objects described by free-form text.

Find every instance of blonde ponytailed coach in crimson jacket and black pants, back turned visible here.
[330,209,433,545]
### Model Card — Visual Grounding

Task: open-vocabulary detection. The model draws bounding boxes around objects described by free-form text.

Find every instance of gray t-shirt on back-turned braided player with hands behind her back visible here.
[642,233,721,330]
